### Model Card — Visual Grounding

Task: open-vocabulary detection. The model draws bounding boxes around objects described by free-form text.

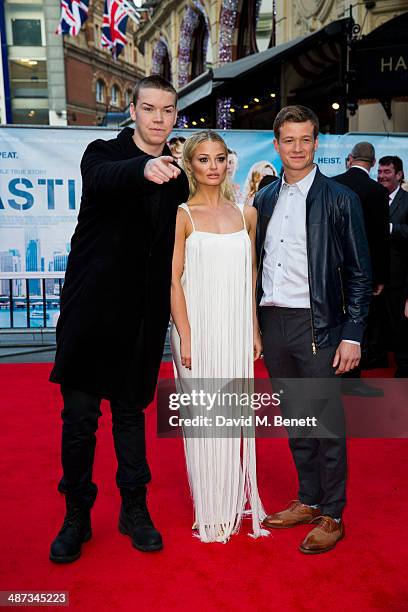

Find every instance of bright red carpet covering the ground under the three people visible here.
[0,364,408,612]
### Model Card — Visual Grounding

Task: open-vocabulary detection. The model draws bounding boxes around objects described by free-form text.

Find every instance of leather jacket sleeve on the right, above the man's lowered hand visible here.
[342,192,372,342]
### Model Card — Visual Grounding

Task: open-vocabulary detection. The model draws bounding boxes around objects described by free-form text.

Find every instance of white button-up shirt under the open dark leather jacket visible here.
[261,166,316,308]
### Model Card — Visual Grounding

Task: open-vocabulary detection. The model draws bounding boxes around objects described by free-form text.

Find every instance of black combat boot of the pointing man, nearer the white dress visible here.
[119,485,163,552]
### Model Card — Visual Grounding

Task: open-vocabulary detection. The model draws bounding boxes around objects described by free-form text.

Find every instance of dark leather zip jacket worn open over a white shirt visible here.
[254,169,372,352]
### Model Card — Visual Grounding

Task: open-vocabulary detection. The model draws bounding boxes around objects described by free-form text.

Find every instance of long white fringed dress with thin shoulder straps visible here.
[170,204,268,542]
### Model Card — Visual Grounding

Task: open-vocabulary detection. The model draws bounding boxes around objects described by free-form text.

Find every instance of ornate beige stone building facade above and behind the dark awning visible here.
[135,0,408,132]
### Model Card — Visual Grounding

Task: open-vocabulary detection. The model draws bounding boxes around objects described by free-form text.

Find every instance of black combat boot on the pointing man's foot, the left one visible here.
[50,495,92,563]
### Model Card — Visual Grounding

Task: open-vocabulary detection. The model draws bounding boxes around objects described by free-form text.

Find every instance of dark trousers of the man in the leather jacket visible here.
[260,306,347,518]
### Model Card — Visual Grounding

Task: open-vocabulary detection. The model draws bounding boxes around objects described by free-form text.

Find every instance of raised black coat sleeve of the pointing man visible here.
[81,140,157,195]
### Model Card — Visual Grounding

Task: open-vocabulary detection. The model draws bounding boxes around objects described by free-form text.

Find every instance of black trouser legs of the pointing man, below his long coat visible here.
[60,386,151,506]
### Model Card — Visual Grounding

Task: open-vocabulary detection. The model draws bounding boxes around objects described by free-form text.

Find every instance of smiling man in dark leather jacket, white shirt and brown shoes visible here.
[254,106,372,554]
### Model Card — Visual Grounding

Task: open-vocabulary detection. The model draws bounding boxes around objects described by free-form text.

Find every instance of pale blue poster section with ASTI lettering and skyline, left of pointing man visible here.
[0,128,116,297]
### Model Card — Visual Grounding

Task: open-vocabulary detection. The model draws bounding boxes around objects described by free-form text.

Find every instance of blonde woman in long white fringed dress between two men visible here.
[170,130,266,542]
